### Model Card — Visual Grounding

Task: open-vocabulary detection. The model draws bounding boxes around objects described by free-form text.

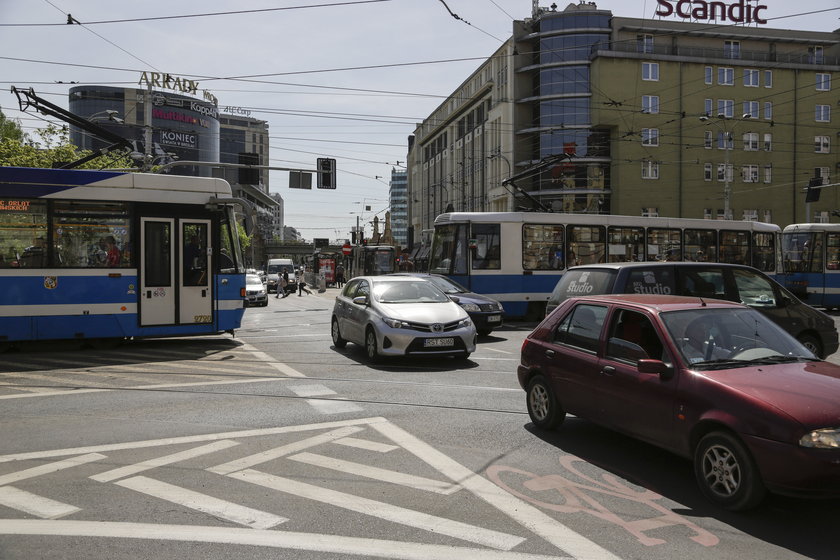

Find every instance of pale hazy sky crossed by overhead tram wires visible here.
[0,0,840,240]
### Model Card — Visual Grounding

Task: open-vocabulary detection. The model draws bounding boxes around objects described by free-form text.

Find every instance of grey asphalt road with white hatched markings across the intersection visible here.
[0,289,840,560]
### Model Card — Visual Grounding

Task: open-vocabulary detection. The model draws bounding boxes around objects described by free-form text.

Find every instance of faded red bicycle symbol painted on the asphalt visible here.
[487,455,720,546]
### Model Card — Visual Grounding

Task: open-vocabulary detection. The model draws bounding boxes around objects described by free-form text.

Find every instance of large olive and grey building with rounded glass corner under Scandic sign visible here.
[408,2,840,244]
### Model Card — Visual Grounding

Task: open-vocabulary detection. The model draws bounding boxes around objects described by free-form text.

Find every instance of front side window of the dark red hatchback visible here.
[607,309,669,364]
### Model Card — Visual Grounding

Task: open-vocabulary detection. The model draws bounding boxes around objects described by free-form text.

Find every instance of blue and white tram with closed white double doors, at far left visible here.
[0,167,245,347]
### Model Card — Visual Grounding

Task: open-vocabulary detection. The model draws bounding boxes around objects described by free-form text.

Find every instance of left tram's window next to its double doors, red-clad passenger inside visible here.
[52,201,133,268]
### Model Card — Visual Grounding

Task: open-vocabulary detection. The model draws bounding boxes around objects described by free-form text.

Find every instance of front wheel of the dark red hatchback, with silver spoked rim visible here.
[694,432,767,511]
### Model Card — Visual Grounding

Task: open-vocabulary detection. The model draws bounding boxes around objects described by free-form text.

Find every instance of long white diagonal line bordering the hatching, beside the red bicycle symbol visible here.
[371,423,619,560]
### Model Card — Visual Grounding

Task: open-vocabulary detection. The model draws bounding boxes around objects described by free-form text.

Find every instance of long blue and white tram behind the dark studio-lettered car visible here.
[429,212,781,318]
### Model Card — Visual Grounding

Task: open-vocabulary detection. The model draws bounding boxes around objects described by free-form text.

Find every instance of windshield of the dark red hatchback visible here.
[660,307,817,369]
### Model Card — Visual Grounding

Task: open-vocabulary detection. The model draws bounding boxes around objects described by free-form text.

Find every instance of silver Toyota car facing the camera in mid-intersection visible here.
[332,276,476,362]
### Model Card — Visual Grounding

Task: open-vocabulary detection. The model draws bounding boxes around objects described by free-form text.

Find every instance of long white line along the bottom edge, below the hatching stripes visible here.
[0,519,568,560]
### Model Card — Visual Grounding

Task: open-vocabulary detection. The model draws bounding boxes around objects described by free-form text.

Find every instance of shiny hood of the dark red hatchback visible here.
[703,362,840,427]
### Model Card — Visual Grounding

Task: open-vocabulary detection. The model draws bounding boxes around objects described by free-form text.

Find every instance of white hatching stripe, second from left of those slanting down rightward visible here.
[114,476,288,529]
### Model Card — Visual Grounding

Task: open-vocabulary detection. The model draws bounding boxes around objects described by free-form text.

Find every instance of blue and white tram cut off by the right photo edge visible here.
[777,224,840,308]
